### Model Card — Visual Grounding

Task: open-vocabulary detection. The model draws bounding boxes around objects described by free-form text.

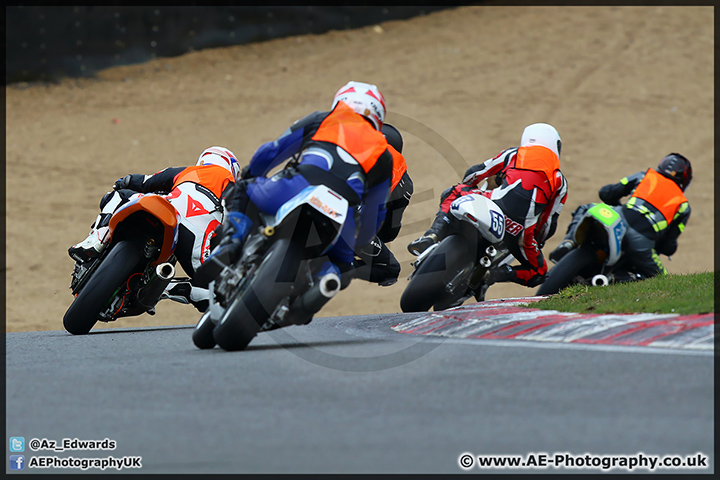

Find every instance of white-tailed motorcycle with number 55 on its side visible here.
[400,193,515,312]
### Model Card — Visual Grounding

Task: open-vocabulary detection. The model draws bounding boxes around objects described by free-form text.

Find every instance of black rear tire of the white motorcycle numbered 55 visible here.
[400,235,475,312]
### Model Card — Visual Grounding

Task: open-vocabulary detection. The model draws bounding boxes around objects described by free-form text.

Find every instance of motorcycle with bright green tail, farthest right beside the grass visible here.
[537,203,632,295]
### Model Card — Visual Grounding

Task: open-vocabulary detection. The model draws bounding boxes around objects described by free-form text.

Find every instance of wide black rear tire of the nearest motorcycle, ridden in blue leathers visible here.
[213,239,302,351]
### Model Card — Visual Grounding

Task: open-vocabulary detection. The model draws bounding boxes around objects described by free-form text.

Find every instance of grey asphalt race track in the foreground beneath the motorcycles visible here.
[6,314,714,474]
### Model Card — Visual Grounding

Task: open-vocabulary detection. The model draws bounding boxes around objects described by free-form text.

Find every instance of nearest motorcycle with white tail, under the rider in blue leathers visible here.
[192,185,348,351]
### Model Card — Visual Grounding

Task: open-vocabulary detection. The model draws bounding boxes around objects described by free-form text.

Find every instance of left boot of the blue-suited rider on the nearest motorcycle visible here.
[193,212,253,287]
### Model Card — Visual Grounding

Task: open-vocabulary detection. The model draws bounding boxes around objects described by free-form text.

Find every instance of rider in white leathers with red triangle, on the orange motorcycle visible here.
[68,146,240,311]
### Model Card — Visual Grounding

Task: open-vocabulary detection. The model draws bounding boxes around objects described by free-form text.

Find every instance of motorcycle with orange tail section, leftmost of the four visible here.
[63,193,180,335]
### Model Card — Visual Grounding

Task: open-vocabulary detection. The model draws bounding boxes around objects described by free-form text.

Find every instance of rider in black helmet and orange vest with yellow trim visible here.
[549,153,692,282]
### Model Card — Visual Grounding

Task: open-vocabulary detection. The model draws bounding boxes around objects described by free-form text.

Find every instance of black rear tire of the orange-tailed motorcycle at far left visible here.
[63,240,142,335]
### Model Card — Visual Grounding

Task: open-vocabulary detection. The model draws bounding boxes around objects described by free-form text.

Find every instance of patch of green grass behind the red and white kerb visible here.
[527,272,715,315]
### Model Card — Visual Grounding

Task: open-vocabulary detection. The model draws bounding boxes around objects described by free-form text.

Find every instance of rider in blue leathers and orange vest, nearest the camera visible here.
[198,81,393,316]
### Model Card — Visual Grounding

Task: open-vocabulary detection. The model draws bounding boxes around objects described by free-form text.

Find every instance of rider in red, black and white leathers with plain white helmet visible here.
[408,123,567,287]
